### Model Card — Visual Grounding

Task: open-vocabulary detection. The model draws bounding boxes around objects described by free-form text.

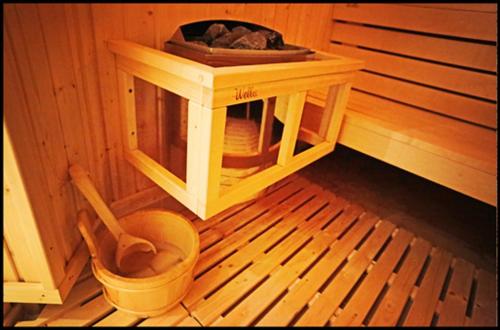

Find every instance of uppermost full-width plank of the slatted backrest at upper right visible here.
[333,4,496,41]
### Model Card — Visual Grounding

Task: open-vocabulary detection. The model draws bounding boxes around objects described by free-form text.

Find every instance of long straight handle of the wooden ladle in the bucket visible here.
[69,164,125,241]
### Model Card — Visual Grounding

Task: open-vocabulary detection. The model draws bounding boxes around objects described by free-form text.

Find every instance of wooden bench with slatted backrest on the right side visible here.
[308,4,497,206]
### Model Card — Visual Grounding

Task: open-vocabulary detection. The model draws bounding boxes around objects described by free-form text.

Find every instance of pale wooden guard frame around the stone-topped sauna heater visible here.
[108,40,363,219]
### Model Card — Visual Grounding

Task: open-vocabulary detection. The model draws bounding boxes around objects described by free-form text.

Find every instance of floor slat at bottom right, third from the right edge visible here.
[403,249,452,326]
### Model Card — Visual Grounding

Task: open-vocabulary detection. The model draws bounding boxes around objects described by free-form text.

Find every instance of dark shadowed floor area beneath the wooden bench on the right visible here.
[300,145,497,272]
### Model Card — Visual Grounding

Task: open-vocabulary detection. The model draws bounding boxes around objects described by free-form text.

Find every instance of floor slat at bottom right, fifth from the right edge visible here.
[331,228,413,326]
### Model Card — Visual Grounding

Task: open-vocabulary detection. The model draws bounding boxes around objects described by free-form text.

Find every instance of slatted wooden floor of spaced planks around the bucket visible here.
[17,175,497,326]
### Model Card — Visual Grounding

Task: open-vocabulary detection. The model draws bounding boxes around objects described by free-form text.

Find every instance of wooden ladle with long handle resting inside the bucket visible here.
[69,164,157,273]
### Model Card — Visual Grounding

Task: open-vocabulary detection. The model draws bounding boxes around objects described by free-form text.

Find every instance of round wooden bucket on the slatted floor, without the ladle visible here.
[92,210,200,317]
